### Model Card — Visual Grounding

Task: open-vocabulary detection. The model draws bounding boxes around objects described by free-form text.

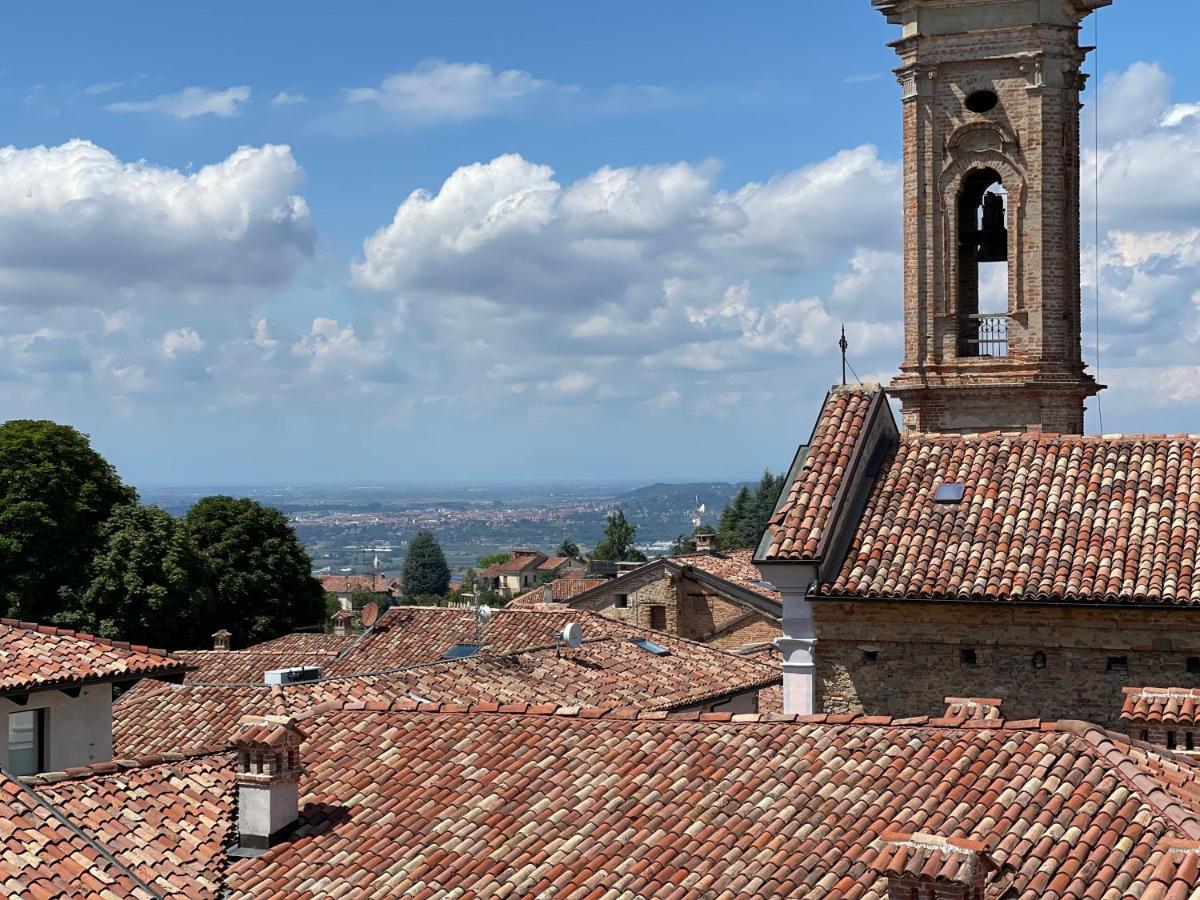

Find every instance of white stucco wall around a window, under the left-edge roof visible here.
[0,684,113,772]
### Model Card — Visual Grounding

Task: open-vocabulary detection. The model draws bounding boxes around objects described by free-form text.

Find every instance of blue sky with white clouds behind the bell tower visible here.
[0,0,1200,484]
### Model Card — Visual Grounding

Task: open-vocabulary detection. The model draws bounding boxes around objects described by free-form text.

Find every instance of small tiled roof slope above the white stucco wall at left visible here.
[0,619,187,691]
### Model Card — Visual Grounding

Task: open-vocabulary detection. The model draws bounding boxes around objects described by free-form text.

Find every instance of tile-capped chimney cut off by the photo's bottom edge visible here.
[868,830,998,900]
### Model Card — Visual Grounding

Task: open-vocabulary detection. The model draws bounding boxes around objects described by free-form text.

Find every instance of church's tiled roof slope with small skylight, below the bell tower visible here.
[822,433,1200,605]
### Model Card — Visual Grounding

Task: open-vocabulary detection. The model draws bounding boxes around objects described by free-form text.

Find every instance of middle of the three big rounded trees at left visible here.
[62,505,217,649]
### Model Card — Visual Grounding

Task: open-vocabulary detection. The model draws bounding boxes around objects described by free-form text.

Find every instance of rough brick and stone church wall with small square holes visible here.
[814,602,1200,731]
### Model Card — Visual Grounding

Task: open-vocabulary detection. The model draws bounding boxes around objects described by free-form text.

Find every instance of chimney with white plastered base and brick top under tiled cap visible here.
[233,715,305,856]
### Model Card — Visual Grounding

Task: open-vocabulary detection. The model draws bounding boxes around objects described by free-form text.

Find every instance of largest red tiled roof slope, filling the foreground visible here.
[216,707,1200,900]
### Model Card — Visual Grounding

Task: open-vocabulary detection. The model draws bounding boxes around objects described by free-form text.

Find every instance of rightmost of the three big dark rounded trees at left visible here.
[185,497,325,644]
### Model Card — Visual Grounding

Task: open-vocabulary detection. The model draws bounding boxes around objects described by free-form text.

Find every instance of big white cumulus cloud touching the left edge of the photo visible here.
[0,140,316,306]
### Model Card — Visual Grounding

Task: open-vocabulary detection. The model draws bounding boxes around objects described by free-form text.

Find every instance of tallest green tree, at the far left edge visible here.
[0,420,137,622]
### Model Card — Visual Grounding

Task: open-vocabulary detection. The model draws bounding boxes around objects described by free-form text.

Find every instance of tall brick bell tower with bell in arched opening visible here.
[872,0,1112,434]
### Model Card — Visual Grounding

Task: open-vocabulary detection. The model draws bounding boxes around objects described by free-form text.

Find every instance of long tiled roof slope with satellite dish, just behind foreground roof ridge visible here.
[113,613,782,756]
